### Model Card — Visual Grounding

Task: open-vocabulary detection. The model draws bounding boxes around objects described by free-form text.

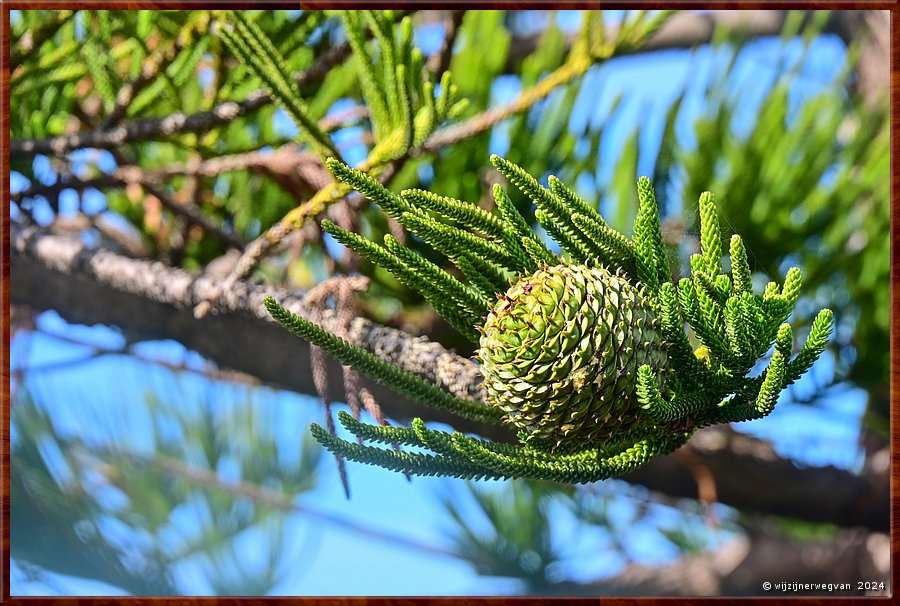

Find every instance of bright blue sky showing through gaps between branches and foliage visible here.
[10,13,865,595]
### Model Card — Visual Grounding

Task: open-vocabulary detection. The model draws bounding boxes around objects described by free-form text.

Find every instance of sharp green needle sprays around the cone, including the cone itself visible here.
[266,156,832,483]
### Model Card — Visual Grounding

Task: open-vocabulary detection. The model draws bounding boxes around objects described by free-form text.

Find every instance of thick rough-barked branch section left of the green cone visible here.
[10,224,492,440]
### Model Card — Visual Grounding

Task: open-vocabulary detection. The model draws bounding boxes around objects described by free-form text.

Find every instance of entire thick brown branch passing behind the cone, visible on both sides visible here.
[10,225,890,530]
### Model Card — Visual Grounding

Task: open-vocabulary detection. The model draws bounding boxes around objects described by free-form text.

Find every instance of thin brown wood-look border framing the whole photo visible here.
[0,0,900,606]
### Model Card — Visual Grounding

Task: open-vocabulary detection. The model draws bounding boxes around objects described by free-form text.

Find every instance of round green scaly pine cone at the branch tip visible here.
[478,264,666,447]
